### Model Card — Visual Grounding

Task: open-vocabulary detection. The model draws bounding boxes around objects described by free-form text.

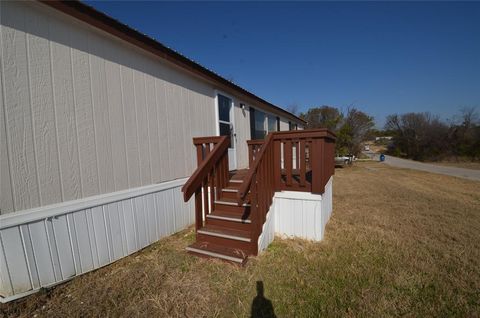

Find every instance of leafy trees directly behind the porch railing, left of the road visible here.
[300,106,375,155]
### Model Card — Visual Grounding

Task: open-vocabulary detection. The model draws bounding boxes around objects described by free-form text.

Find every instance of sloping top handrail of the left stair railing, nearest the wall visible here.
[182,136,230,202]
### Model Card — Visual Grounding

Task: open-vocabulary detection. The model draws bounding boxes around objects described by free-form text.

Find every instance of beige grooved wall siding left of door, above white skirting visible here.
[0,2,215,214]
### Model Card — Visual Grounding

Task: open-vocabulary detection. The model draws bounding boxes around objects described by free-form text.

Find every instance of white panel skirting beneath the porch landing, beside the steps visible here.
[258,176,333,252]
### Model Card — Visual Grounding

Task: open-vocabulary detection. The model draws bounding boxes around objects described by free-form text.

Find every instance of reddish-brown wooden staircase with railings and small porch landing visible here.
[182,129,335,265]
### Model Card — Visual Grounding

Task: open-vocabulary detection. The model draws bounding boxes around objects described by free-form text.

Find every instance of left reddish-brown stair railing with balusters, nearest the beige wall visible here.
[182,136,230,230]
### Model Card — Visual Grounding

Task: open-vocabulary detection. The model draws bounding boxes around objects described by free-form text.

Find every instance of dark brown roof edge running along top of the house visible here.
[39,0,306,123]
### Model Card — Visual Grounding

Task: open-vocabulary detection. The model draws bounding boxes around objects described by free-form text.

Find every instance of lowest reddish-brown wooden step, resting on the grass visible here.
[186,242,247,265]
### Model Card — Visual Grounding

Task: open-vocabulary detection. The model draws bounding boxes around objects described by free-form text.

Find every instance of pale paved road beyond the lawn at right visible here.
[367,153,480,181]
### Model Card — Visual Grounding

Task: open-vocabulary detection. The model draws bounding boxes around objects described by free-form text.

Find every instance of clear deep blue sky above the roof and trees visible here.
[84,1,480,127]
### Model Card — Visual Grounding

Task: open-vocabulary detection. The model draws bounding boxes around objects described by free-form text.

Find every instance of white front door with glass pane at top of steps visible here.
[217,94,237,170]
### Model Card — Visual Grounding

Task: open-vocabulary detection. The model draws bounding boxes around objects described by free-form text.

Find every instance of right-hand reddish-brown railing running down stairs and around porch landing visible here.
[242,129,335,251]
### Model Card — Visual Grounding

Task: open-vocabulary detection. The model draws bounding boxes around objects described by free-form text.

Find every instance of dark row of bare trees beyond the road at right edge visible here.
[385,108,480,161]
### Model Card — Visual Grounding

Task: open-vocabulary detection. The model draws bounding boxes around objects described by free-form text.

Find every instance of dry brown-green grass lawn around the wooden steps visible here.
[0,162,480,317]
